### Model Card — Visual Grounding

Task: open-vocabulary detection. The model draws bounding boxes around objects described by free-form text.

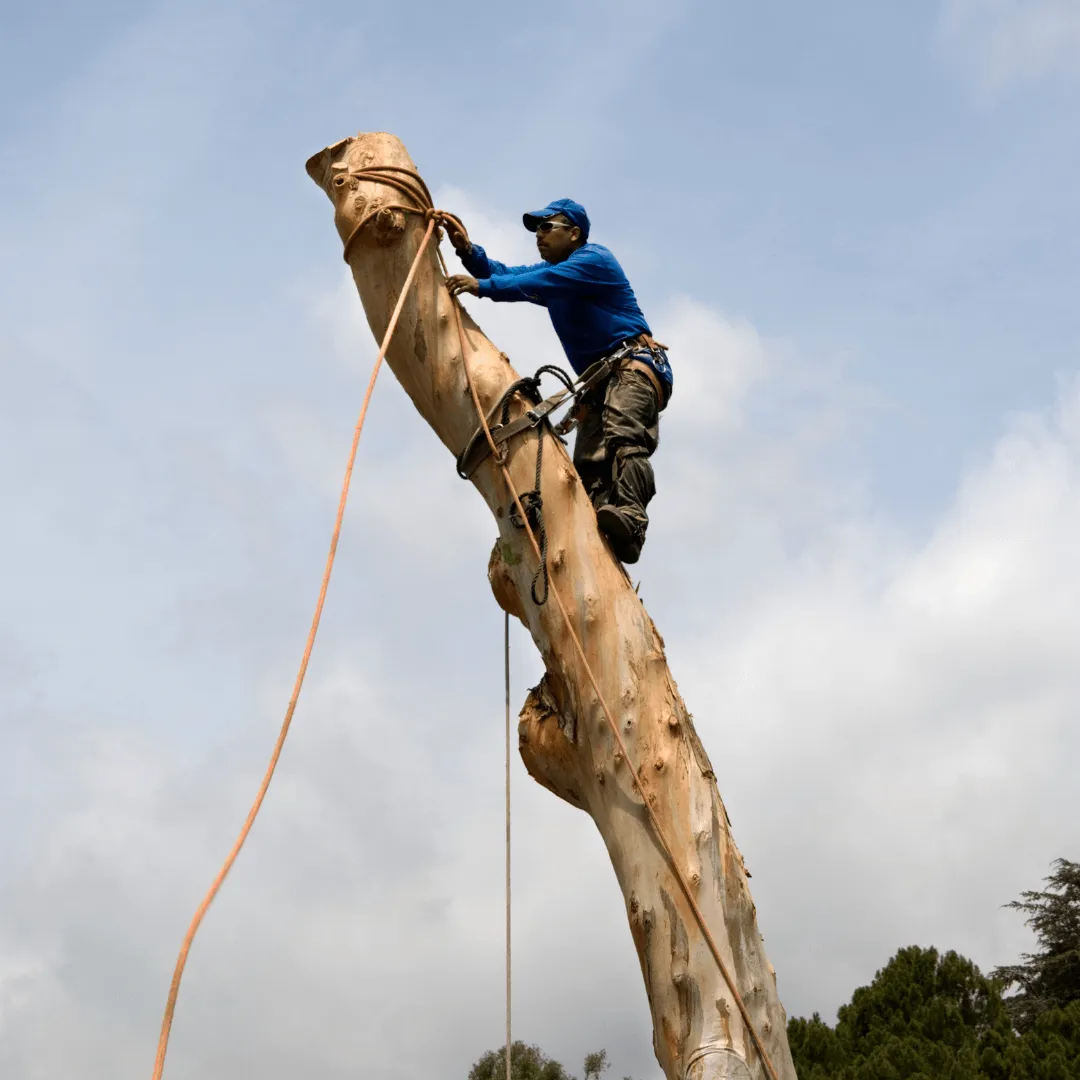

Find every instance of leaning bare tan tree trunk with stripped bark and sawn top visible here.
[307,133,795,1080]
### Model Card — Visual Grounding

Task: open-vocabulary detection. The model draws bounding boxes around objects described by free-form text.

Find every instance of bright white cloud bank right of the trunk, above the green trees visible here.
[651,371,1080,1012]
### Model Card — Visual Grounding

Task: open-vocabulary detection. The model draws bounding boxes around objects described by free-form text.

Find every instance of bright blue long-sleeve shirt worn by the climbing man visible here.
[460,244,671,387]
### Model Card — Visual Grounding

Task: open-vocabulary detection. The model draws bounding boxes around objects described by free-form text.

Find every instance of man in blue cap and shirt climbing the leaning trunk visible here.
[447,199,672,563]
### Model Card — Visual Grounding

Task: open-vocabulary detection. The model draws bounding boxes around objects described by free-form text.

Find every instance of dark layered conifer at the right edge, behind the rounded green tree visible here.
[994,859,1080,1031]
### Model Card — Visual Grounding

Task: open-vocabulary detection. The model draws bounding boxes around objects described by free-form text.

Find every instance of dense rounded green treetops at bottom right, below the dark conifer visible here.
[787,946,1080,1080]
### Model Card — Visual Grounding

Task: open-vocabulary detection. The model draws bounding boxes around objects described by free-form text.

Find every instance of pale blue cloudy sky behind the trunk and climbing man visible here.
[0,0,1080,1080]
